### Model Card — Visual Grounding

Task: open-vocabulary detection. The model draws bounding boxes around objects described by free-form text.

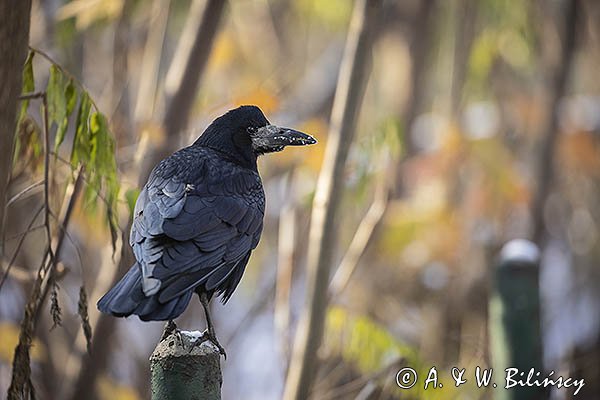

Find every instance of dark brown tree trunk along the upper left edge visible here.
[0,0,31,258]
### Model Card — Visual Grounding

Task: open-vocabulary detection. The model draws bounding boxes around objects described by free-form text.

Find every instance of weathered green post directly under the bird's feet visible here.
[150,330,223,400]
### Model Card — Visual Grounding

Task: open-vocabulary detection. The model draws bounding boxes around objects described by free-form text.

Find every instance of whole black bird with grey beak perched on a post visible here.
[98,106,317,354]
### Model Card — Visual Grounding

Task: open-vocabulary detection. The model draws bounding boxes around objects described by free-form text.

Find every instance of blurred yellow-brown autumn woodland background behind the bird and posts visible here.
[0,0,600,400]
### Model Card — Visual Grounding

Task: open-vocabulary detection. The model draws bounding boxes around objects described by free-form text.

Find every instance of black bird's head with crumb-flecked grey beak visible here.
[196,106,317,167]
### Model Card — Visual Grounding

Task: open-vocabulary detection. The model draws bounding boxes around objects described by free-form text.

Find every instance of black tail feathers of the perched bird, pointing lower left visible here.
[97,263,194,321]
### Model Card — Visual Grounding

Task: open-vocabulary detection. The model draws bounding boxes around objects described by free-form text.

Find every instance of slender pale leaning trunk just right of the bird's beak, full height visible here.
[284,0,382,400]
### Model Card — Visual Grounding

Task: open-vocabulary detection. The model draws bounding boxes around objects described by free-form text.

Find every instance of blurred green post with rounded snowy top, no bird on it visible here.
[489,239,547,400]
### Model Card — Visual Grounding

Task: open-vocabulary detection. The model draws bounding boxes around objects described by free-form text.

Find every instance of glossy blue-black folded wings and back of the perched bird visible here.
[130,153,264,303]
